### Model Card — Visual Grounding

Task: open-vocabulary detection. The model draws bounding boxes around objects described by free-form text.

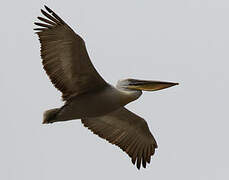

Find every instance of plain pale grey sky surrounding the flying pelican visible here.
[0,0,229,180]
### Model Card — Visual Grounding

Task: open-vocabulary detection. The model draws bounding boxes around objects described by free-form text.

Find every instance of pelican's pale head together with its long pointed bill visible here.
[117,79,178,91]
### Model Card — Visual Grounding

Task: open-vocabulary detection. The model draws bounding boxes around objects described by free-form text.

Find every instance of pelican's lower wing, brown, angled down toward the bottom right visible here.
[81,107,157,169]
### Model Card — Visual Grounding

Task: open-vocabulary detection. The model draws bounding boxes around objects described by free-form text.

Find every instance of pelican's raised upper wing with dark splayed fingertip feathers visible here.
[34,6,106,100]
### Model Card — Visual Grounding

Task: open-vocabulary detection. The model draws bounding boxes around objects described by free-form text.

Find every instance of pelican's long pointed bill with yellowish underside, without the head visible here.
[127,79,179,91]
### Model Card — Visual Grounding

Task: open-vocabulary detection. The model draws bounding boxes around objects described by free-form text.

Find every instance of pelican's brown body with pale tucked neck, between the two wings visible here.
[48,84,142,123]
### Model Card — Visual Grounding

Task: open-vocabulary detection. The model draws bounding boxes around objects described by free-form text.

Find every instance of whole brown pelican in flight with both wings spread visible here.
[34,6,178,169]
